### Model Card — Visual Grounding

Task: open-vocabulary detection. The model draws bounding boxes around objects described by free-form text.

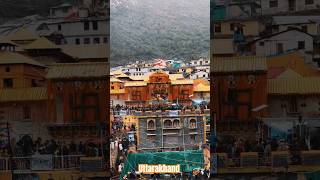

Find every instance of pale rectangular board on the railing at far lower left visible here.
[31,155,53,171]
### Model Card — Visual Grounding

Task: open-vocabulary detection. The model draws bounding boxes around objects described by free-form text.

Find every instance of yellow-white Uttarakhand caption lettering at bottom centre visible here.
[138,164,180,174]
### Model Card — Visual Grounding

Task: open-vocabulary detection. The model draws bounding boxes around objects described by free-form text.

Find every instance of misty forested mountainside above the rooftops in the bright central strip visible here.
[110,0,210,65]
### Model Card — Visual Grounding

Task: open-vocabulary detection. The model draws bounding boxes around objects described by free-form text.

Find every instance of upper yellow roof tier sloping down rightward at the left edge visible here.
[0,51,45,67]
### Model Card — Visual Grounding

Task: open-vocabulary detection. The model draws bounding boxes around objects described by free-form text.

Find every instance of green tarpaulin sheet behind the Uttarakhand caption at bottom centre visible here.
[120,150,204,179]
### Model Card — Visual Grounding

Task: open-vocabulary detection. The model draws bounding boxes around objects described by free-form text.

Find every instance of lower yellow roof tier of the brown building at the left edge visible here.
[0,87,48,102]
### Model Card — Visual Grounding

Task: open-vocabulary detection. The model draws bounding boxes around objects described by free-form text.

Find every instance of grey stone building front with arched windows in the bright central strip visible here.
[135,110,206,152]
